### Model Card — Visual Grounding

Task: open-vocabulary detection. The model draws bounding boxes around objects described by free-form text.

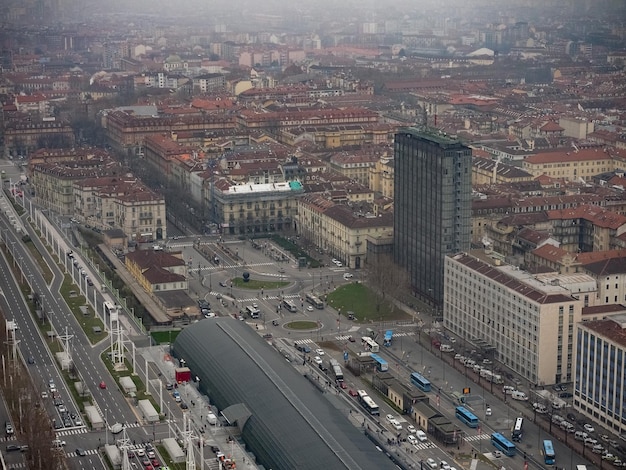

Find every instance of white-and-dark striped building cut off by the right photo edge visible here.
[573,313,626,436]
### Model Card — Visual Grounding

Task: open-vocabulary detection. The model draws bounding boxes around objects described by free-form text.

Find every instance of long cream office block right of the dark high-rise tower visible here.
[443,250,596,386]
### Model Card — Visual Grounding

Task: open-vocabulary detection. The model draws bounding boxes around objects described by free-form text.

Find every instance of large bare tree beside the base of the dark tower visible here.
[366,253,409,317]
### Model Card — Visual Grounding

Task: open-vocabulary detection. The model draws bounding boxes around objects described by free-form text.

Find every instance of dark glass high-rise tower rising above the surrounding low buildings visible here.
[393,128,472,307]
